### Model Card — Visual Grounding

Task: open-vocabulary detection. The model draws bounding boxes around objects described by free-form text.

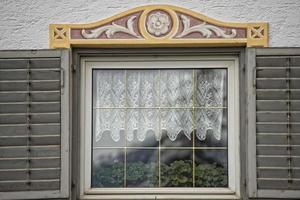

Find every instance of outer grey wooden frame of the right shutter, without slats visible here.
[246,47,300,198]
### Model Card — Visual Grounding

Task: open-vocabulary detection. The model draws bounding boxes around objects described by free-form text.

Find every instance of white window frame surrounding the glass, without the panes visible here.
[80,56,240,199]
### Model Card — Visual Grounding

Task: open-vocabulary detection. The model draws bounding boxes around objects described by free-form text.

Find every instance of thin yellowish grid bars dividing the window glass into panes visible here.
[92,69,227,187]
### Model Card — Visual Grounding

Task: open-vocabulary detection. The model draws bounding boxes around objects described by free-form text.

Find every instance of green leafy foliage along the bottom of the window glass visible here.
[92,160,228,188]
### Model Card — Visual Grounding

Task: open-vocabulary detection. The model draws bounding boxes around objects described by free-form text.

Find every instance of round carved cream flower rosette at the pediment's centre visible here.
[146,11,171,37]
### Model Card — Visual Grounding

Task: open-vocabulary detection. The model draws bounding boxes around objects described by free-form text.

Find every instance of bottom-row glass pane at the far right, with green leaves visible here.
[195,150,228,187]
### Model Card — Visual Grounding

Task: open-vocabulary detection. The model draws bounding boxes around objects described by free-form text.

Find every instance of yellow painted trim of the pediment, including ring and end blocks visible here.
[49,5,268,48]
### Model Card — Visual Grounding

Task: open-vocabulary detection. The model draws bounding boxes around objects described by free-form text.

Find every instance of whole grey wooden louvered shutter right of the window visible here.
[247,48,300,198]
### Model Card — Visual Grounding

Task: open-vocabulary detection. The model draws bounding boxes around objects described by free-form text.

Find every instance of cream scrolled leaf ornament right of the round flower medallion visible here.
[176,15,237,38]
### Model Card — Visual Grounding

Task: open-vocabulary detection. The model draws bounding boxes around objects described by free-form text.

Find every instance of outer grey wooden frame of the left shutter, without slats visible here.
[0,49,71,199]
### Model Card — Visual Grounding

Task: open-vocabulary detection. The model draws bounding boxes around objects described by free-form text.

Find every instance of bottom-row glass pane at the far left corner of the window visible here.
[91,149,125,187]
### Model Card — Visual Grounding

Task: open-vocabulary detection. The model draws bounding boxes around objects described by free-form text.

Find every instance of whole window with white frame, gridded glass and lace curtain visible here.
[81,56,239,197]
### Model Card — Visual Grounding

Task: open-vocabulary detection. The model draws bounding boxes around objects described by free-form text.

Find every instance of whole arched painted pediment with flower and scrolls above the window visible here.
[50,5,268,48]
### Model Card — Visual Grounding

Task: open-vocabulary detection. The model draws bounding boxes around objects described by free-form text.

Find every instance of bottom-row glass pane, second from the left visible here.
[126,149,158,187]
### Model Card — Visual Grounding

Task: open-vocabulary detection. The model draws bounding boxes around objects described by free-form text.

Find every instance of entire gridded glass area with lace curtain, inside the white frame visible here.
[91,68,228,187]
